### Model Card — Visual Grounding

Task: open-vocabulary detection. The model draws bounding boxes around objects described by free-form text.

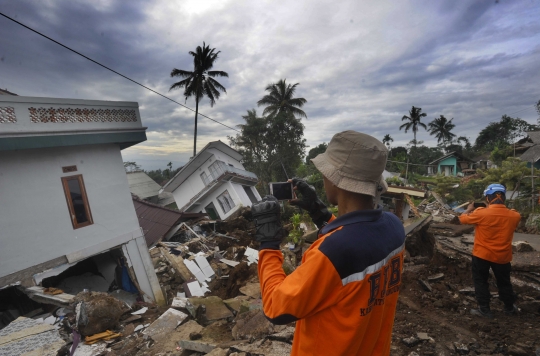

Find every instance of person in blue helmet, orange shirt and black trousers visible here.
[459,184,521,318]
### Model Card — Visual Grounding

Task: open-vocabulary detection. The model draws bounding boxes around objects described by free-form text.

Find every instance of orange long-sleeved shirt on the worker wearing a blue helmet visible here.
[459,204,521,264]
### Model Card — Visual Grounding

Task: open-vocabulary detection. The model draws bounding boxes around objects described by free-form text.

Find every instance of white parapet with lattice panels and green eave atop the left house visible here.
[0,95,146,151]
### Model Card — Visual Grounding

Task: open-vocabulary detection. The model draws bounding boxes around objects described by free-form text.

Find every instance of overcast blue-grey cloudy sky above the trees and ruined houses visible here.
[0,0,540,169]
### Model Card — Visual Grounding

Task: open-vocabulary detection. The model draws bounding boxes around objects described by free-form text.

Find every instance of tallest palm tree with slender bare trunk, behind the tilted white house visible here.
[169,42,229,157]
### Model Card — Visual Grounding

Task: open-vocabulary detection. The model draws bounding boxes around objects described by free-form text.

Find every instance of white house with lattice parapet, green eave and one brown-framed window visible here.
[0,96,163,315]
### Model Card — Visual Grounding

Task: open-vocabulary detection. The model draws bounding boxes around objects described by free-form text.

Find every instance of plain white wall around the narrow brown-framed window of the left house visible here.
[0,144,140,277]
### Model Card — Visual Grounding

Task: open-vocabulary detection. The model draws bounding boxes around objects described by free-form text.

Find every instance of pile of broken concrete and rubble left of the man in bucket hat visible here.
[0,208,301,356]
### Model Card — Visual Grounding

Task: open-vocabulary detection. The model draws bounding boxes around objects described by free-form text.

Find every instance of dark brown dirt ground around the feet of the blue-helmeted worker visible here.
[391,253,540,356]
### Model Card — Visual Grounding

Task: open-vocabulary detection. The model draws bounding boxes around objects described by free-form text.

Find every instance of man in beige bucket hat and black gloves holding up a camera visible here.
[251,131,405,356]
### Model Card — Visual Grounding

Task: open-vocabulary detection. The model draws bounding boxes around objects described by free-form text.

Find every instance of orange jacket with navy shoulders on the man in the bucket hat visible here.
[258,210,405,356]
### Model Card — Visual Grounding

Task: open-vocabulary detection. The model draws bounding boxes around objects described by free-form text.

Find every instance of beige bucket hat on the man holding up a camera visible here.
[311,130,388,197]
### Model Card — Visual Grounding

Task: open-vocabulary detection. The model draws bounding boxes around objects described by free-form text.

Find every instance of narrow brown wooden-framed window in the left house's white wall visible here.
[62,174,94,229]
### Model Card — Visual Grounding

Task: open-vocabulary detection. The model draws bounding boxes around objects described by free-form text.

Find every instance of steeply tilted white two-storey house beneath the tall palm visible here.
[163,141,261,220]
